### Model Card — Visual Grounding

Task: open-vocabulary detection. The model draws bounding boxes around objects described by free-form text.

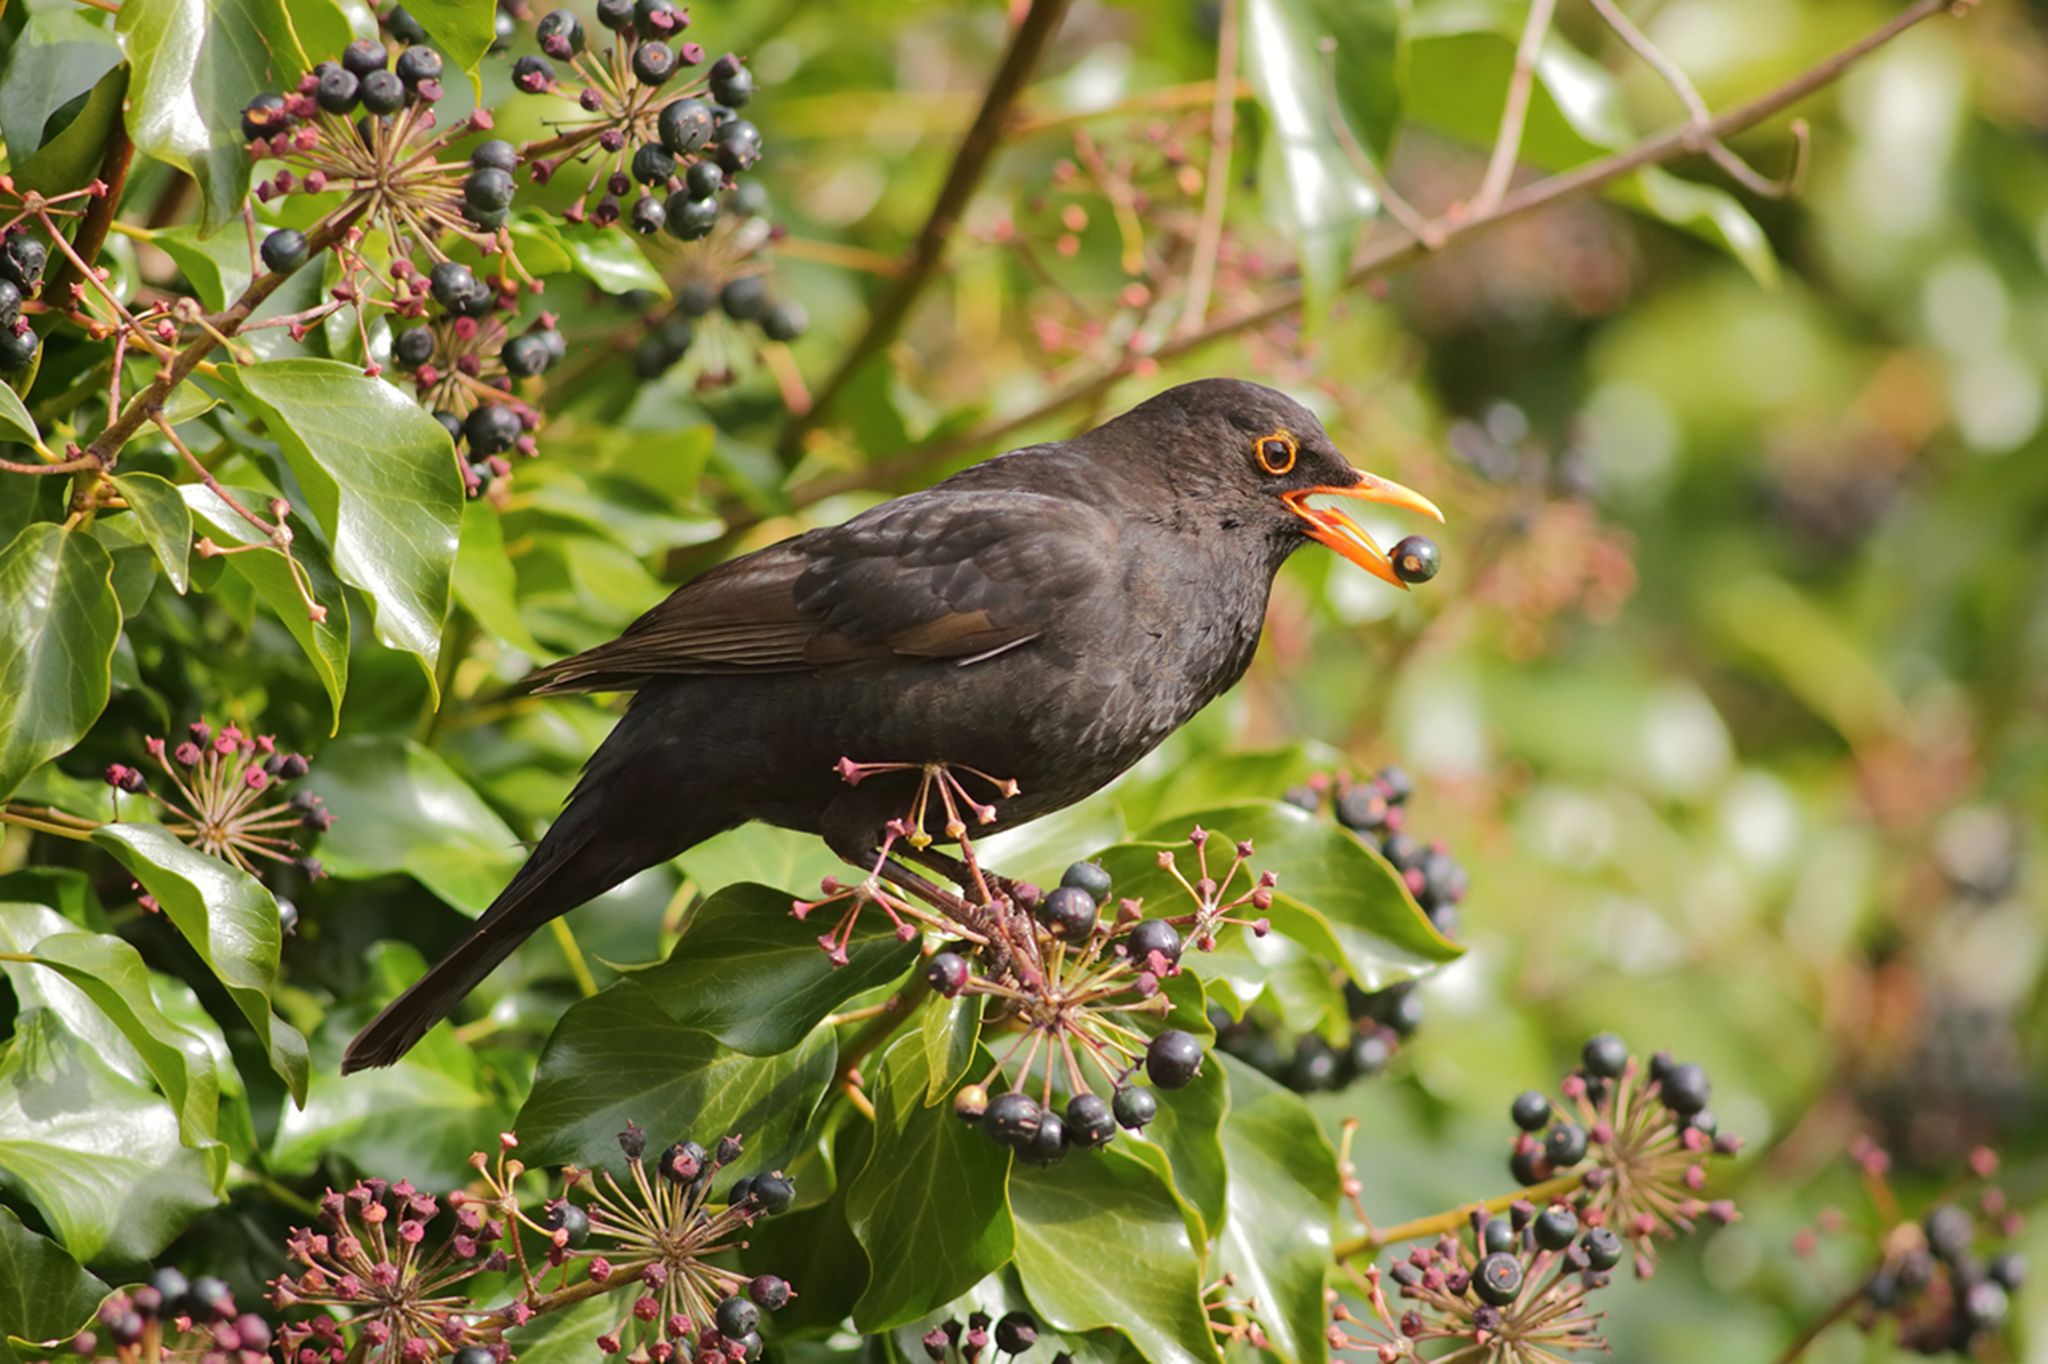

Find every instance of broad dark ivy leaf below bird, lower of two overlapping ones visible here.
[518,977,838,1169]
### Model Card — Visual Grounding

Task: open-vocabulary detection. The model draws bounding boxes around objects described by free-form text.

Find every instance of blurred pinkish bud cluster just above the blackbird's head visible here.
[977,115,1300,375]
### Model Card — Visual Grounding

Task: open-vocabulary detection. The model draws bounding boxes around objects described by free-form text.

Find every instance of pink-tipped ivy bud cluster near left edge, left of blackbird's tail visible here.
[104,721,334,877]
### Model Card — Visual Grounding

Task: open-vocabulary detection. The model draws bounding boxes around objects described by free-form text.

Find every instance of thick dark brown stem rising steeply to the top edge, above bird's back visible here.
[778,0,1069,459]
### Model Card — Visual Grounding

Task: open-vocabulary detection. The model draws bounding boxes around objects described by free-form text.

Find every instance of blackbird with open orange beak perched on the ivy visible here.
[342,379,1442,1073]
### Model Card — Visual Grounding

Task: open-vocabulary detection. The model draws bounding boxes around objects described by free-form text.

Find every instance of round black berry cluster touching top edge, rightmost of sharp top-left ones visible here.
[512,0,762,231]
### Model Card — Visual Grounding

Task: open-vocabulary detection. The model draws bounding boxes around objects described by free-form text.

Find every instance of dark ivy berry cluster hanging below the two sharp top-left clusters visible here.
[391,286,569,496]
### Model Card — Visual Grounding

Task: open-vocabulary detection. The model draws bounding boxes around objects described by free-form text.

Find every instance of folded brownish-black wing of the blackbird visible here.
[520,489,1114,692]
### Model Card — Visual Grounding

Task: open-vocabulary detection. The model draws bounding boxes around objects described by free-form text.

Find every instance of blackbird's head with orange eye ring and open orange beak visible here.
[1094,379,1444,590]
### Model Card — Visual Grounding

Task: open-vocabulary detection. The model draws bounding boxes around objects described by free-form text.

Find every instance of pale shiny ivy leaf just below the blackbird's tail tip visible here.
[268,942,512,1188]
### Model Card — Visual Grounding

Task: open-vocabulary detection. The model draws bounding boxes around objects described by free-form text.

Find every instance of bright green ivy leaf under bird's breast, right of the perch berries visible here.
[1102,801,1462,989]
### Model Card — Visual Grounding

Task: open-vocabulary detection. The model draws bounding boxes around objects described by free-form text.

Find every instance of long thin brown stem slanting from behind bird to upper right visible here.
[708,0,1974,548]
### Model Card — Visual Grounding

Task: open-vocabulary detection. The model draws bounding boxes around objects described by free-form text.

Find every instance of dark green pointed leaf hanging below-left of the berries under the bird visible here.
[846,1036,1011,1331]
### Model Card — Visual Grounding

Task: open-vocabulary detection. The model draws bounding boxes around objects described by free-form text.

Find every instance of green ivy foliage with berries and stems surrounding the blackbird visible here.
[0,0,2048,1364]
